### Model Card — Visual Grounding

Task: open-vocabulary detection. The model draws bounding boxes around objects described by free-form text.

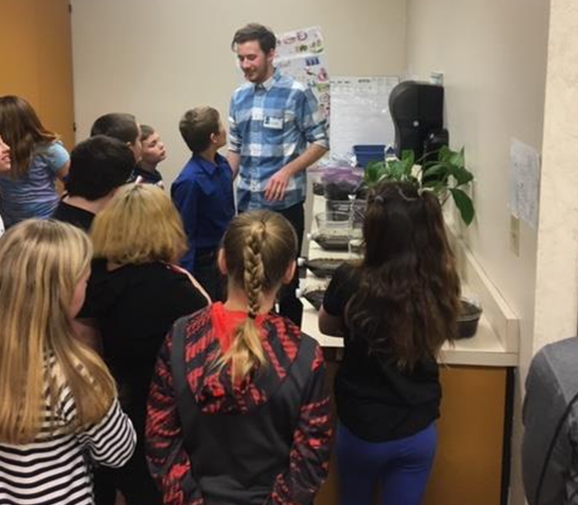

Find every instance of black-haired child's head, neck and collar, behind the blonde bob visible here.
[52,135,134,231]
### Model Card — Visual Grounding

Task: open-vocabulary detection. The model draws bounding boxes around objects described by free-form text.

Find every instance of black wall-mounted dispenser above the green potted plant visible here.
[389,81,449,163]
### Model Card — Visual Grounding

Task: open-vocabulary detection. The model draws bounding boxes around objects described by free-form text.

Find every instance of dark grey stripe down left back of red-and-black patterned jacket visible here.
[171,316,197,455]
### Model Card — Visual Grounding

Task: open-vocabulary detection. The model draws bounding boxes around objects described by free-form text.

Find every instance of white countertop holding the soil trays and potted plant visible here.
[301,196,518,367]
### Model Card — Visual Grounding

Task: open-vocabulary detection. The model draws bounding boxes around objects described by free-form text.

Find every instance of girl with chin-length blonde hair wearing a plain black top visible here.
[80,184,208,505]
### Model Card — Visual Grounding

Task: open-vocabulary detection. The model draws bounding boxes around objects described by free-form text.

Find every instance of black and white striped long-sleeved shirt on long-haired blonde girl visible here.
[0,360,136,505]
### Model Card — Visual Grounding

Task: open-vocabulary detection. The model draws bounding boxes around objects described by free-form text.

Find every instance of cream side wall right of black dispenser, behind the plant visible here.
[407,0,548,504]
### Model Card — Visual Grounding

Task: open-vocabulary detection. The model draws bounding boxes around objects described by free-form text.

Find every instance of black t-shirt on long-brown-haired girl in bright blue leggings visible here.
[323,264,441,442]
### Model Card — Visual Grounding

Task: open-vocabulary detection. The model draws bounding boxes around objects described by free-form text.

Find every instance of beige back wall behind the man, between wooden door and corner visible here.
[72,0,405,182]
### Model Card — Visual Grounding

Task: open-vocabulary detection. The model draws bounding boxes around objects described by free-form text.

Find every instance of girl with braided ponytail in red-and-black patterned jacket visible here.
[146,211,331,505]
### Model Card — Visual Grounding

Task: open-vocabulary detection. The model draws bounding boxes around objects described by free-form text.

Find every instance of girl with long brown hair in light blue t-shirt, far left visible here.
[0,95,70,227]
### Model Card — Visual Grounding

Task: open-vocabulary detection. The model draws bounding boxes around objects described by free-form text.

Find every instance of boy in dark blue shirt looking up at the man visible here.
[171,107,235,301]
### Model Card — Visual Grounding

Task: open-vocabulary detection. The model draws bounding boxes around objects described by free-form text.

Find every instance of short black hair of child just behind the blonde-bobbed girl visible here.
[66,135,134,201]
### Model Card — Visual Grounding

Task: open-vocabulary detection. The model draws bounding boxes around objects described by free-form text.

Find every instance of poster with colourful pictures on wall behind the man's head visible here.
[274,26,331,122]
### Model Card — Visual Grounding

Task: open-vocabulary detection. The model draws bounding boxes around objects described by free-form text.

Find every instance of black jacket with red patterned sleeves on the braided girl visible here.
[146,304,331,505]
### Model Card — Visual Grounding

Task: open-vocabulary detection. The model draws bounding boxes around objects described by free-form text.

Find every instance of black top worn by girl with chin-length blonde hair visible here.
[78,259,207,426]
